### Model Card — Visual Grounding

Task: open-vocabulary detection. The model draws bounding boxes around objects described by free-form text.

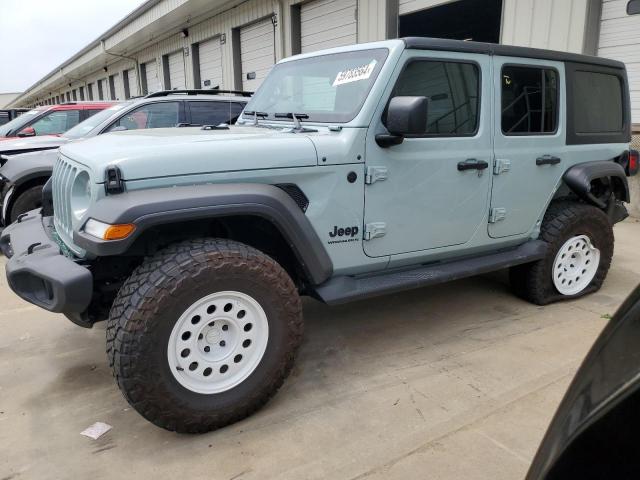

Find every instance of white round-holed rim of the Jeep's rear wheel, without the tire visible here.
[552,235,600,295]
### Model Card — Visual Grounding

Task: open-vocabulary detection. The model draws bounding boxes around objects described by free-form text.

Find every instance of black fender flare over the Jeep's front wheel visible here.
[73,183,333,284]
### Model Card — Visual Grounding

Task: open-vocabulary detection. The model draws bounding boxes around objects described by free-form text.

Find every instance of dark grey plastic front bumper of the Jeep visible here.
[0,210,93,320]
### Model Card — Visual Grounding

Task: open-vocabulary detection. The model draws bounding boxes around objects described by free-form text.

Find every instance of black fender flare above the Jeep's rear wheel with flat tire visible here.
[562,160,630,209]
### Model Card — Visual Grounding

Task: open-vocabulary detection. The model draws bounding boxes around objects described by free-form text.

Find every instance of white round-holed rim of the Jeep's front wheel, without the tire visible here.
[167,291,269,394]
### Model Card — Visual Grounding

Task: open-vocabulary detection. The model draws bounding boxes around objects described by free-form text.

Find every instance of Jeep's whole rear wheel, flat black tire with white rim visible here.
[510,202,614,305]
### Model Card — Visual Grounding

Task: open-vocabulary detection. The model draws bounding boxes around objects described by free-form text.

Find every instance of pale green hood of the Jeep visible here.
[60,126,317,182]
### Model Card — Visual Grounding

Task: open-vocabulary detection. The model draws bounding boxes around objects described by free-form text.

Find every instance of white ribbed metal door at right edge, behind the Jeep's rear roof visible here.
[598,0,640,123]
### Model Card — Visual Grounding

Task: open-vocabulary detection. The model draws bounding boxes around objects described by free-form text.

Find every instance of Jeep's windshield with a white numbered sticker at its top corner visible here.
[243,48,389,123]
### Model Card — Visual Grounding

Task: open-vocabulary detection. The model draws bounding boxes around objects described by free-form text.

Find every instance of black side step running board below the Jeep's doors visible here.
[314,240,548,305]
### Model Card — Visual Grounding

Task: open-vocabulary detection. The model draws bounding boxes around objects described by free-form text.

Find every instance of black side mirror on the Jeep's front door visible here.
[376,97,429,148]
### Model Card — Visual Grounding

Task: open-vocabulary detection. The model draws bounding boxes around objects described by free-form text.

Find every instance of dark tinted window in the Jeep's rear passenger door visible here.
[501,65,558,135]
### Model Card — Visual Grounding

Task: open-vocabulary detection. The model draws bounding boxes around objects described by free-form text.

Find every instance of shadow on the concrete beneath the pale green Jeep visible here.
[30,273,539,442]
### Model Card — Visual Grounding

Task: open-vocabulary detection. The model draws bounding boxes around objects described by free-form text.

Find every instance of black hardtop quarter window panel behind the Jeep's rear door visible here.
[566,63,631,145]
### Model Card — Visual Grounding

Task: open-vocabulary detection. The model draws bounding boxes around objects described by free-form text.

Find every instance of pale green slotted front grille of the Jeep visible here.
[51,155,80,246]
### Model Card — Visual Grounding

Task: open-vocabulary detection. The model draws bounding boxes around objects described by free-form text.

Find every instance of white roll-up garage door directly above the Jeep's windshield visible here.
[300,0,358,53]
